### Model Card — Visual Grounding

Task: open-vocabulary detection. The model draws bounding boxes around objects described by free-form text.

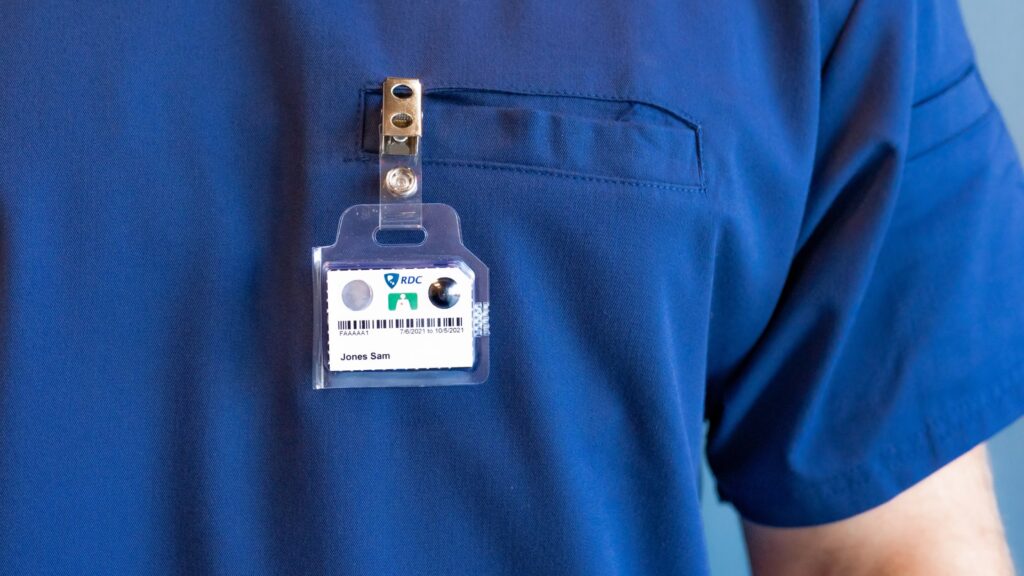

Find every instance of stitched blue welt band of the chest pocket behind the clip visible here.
[361,88,703,189]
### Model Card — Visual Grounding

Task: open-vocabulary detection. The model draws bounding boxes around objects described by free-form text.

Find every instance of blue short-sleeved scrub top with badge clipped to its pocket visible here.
[0,0,1024,574]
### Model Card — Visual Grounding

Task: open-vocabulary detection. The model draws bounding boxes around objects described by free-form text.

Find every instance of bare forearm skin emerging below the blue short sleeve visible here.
[743,446,1014,576]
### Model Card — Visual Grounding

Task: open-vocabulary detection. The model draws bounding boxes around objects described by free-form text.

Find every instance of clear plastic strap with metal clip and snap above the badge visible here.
[379,78,423,230]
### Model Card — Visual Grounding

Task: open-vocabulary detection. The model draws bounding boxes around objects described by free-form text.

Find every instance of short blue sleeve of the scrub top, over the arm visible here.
[708,0,1024,526]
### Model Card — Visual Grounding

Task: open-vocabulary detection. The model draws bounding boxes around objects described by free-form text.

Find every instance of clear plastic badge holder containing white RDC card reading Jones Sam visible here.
[313,204,489,388]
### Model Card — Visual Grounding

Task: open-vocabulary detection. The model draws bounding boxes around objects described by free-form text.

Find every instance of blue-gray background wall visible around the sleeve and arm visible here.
[703,0,1024,576]
